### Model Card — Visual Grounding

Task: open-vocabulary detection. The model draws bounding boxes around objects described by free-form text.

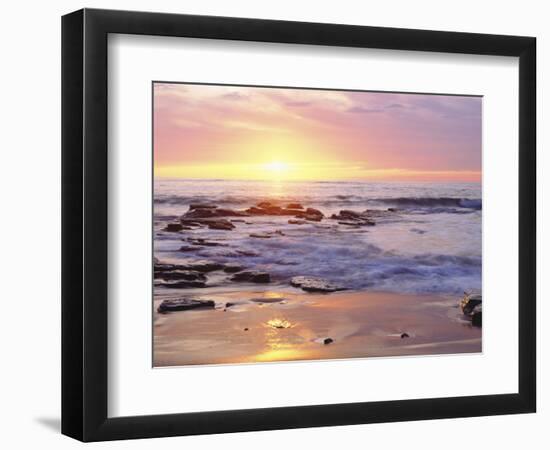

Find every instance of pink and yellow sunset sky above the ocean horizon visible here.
[153,83,482,181]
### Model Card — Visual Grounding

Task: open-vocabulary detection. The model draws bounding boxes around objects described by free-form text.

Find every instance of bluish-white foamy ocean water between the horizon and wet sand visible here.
[153,179,482,295]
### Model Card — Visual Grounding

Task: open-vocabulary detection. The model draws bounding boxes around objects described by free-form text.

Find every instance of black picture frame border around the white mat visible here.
[62,9,536,441]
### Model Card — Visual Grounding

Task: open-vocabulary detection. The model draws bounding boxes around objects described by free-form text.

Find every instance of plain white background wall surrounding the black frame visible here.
[0,0,550,450]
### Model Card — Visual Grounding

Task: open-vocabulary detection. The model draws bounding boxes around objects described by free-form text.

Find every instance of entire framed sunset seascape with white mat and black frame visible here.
[62,9,536,441]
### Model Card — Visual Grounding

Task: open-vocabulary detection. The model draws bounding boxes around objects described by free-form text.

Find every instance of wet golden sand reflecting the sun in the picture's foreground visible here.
[153,286,481,367]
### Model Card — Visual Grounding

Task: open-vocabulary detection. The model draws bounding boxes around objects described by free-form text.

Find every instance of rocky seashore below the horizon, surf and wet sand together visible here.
[153,179,481,367]
